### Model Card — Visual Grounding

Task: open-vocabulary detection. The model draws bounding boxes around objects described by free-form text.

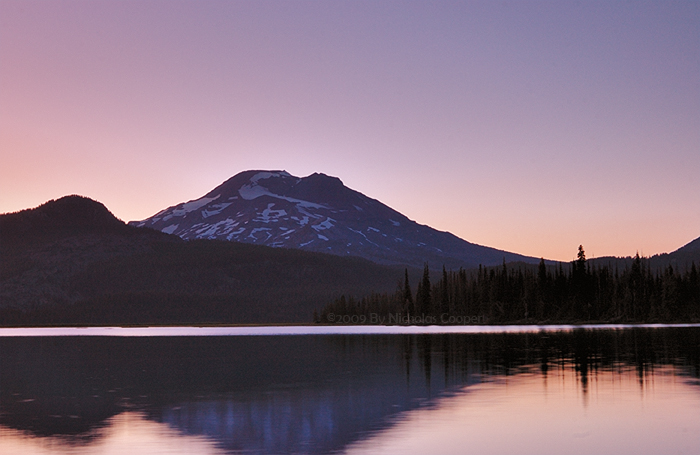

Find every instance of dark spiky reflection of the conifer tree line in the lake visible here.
[329,328,700,393]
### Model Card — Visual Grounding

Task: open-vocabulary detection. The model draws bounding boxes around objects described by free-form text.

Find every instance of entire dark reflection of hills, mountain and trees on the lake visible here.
[0,329,700,453]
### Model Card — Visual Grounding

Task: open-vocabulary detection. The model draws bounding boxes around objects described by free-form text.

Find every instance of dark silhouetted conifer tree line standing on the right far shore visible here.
[314,246,700,324]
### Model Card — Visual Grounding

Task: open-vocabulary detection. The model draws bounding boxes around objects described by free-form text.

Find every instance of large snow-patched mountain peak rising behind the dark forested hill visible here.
[129,171,539,268]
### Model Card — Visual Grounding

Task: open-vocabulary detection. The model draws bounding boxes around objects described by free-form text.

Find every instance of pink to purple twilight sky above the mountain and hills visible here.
[0,0,700,261]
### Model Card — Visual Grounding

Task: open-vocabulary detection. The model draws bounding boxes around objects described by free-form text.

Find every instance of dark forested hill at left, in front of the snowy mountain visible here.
[0,196,410,325]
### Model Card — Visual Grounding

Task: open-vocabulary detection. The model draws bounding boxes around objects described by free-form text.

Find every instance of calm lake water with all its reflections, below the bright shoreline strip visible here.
[0,327,700,455]
